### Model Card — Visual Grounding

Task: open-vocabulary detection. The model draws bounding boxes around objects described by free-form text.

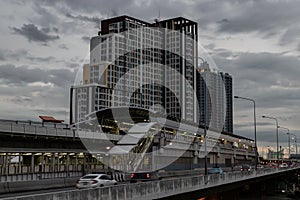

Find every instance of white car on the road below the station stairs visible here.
[76,174,117,189]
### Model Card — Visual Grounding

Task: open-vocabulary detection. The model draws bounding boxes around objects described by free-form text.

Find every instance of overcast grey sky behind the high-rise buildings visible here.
[0,0,300,152]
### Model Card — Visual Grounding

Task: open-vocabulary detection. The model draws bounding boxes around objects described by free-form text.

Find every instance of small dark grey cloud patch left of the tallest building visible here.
[11,24,59,43]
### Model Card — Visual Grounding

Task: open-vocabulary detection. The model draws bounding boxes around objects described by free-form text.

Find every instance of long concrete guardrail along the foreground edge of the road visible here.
[5,167,300,200]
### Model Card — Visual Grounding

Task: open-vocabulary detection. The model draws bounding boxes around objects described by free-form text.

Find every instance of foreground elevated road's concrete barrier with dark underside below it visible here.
[5,167,300,200]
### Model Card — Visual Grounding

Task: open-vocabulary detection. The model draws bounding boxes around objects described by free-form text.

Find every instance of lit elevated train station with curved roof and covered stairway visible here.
[0,107,255,181]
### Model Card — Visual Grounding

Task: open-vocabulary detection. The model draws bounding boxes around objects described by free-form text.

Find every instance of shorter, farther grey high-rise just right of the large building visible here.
[197,62,233,133]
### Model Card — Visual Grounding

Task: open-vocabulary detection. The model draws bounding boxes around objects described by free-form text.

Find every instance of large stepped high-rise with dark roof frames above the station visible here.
[70,16,198,123]
